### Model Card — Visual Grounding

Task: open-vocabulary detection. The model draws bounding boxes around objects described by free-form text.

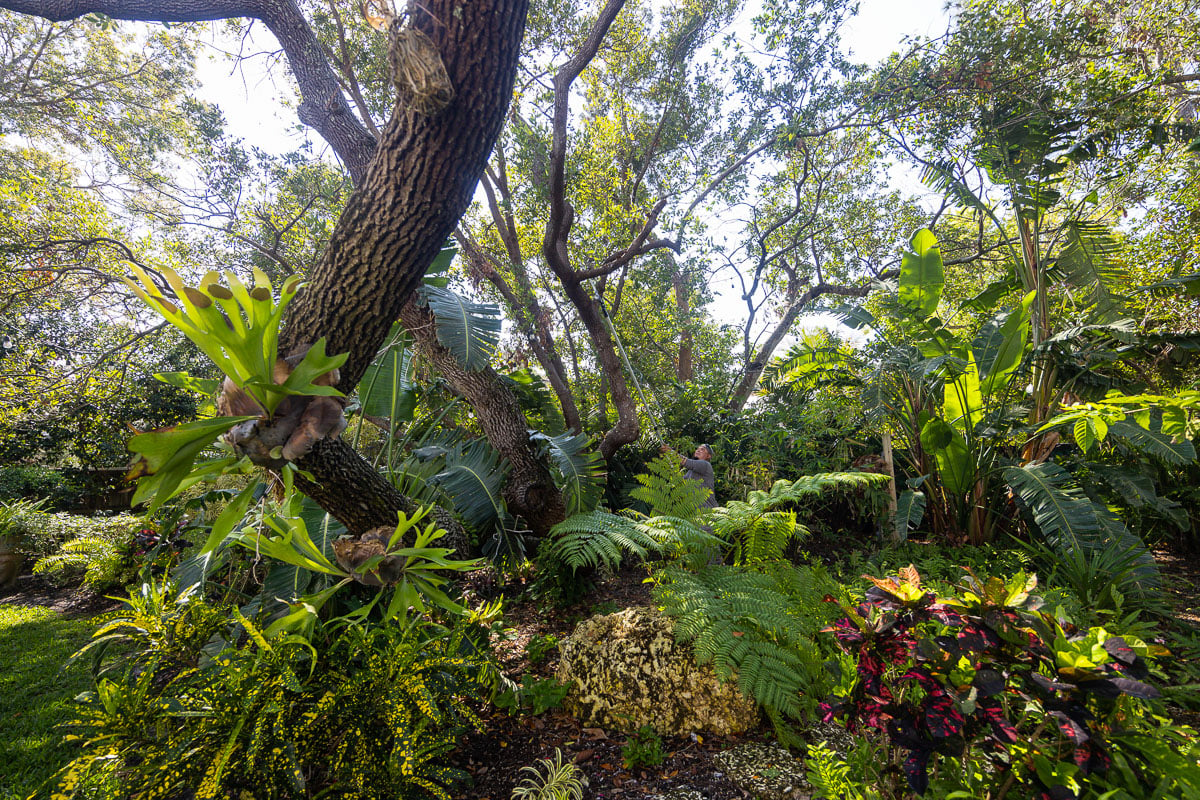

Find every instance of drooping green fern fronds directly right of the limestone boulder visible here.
[654,564,836,742]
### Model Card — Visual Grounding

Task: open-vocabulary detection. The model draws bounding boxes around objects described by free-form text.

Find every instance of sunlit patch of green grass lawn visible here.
[0,603,94,800]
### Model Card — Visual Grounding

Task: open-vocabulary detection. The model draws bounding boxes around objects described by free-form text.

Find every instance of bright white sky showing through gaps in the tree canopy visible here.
[189,0,949,345]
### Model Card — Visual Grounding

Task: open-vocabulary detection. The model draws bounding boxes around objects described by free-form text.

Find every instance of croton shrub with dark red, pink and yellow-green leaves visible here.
[822,567,1200,798]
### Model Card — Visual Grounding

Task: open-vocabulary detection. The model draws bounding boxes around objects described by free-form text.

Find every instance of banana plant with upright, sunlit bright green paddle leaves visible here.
[840,229,1034,543]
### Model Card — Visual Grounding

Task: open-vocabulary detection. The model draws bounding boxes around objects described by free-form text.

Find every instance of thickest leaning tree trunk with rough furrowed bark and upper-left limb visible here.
[7,0,528,533]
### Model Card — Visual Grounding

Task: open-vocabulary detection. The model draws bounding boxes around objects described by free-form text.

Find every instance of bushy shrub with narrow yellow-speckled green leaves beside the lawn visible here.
[56,595,491,800]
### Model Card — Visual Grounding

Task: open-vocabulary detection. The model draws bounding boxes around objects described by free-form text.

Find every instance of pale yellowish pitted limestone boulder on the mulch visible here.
[557,608,758,735]
